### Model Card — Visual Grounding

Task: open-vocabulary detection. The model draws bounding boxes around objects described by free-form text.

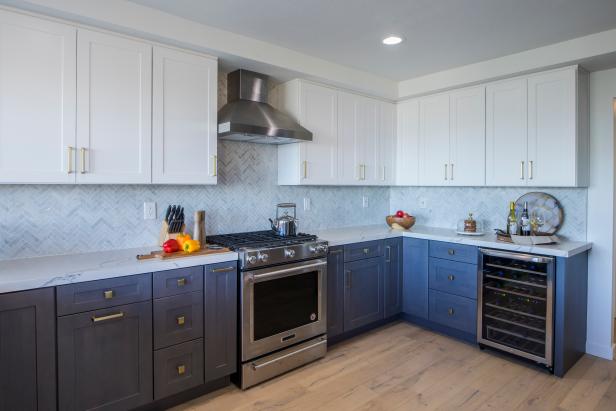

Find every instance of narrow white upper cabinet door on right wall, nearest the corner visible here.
[396,100,419,186]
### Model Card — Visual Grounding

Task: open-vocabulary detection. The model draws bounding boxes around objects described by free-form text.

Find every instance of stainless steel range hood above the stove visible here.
[218,69,312,144]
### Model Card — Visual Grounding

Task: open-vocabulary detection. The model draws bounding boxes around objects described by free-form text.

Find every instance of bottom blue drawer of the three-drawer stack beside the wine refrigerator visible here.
[428,290,477,334]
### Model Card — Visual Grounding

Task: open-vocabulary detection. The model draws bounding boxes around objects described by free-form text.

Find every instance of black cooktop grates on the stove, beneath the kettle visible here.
[206,230,317,250]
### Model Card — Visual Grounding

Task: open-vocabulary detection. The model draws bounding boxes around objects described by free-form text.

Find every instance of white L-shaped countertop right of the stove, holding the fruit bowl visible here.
[316,224,592,257]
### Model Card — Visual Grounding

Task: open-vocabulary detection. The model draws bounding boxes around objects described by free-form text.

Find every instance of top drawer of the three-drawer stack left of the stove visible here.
[152,266,203,298]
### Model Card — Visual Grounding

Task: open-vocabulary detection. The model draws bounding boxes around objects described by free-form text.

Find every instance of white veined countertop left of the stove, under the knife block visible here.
[0,247,238,293]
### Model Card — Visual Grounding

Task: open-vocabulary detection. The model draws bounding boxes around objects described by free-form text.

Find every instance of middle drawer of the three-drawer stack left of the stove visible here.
[154,291,203,349]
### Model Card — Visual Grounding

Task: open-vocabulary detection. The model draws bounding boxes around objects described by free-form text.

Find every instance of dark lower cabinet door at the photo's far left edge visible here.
[0,288,56,411]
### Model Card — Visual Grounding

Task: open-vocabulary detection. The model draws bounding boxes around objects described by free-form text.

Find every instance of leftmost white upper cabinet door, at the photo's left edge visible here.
[0,11,76,183]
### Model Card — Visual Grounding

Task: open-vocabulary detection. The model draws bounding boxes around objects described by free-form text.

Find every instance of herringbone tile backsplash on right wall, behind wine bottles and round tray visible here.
[390,187,587,241]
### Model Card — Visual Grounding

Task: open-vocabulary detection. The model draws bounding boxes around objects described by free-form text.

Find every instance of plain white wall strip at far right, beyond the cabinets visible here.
[586,69,616,359]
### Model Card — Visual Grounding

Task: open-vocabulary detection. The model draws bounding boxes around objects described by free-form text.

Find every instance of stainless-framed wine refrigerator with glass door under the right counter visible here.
[477,249,554,371]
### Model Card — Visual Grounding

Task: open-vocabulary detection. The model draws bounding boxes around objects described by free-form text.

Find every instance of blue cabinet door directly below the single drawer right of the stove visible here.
[344,257,384,332]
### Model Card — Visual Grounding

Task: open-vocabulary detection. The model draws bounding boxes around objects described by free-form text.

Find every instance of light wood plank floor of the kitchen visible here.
[174,323,616,411]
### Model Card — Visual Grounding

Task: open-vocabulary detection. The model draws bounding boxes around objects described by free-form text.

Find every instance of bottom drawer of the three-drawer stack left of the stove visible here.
[154,339,203,400]
